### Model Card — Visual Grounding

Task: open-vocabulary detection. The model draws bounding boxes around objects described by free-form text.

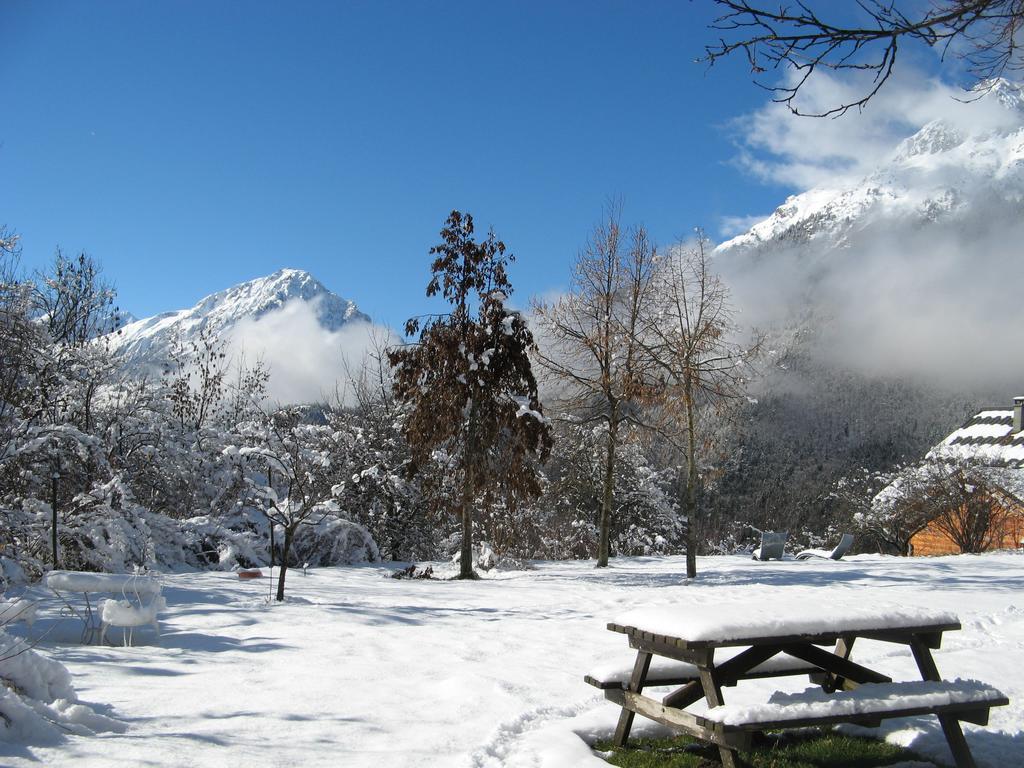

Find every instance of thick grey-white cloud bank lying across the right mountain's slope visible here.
[721,209,1024,388]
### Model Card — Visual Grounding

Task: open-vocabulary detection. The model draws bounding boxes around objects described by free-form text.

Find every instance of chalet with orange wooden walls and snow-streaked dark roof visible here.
[910,397,1024,555]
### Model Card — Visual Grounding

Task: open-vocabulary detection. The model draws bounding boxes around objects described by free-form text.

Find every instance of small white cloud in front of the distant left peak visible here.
[228,299,398,403]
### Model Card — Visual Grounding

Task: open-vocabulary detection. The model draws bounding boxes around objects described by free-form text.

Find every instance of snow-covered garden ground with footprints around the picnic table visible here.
[0,553,1024,768]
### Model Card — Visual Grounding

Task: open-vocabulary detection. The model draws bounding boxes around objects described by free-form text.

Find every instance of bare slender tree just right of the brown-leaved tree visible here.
[535,203,655,567]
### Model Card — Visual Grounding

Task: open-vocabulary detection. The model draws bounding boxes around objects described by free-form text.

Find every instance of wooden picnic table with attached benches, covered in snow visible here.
[586,601,1009,768]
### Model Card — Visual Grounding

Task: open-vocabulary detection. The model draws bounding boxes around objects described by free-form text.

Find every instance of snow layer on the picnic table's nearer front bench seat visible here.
[703,680,1004,725]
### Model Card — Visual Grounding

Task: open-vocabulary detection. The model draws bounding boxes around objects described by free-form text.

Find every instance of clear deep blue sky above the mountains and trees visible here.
[0,0,942,326]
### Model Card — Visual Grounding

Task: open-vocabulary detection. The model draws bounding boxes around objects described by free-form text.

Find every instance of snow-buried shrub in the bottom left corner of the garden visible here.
[0,628,125,744]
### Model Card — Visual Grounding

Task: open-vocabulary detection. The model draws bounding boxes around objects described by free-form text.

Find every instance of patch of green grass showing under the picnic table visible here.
[594,731,921,768]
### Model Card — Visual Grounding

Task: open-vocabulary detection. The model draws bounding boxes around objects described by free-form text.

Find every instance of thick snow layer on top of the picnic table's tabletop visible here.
[613,598,958,642]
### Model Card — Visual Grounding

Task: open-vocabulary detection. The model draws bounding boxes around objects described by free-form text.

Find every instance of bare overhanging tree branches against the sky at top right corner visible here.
[705,0,1024,117]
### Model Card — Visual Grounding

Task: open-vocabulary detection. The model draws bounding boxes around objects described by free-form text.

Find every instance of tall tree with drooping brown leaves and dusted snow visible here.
[388,211,551,579]
